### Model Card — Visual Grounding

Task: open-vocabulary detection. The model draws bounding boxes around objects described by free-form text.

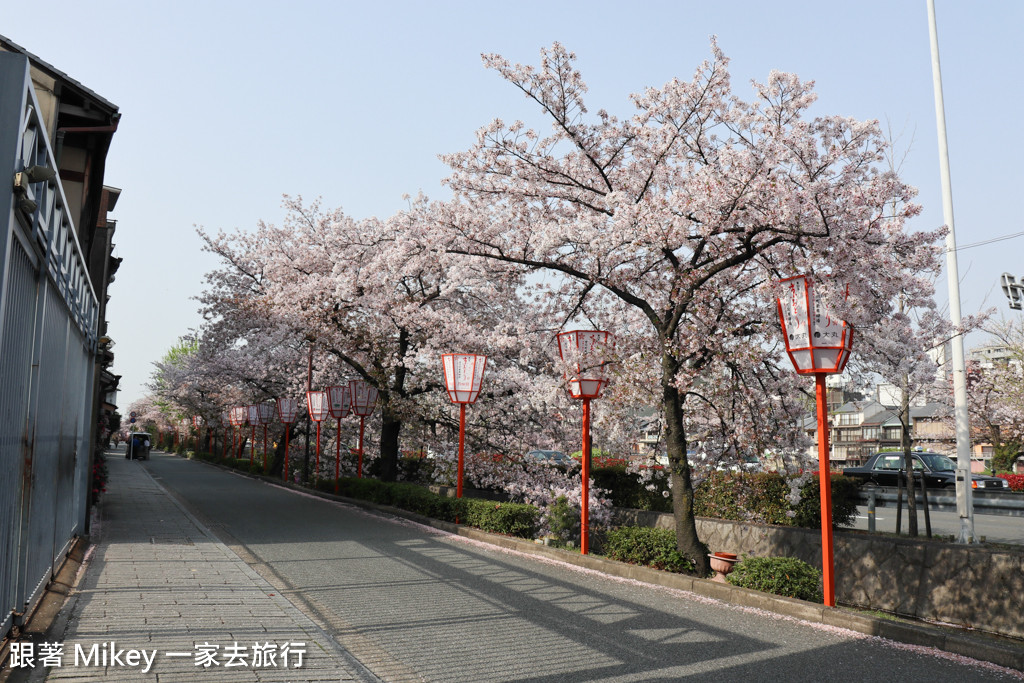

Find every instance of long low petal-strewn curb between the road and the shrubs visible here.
[178,459,1024,672]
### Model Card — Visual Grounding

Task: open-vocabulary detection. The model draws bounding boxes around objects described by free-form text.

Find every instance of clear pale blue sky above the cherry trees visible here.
[0,0,1024,408]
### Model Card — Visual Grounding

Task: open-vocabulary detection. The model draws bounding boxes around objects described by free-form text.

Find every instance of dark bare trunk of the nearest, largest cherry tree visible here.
[662,356,711,577]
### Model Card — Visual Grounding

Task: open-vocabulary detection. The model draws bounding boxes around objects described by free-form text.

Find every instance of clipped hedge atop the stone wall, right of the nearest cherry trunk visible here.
[693,472,858,528]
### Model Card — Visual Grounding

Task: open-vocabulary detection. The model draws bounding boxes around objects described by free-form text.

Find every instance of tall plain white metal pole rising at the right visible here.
[928,0,975,543]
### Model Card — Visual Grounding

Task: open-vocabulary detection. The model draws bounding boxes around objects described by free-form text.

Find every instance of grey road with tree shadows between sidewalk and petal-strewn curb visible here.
[123,454,1016,683]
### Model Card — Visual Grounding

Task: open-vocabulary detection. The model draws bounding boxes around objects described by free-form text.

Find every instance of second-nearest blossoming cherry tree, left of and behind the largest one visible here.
[195,198,573,480]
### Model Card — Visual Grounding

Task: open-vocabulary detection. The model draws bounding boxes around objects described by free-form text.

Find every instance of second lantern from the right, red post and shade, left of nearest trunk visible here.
[558,330,612,555]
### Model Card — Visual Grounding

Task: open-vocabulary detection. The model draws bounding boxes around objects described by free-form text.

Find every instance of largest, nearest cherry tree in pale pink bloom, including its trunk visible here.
[438,42,937,572]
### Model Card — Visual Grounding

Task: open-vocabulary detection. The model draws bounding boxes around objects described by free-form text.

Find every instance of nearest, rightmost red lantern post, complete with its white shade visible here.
[778,275,853,607]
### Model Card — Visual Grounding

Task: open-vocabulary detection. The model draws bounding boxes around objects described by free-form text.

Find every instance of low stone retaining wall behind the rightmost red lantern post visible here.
[614,510,1024,638]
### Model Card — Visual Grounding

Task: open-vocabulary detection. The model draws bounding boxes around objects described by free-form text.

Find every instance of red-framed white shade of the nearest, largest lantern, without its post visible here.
[778,275,853,375]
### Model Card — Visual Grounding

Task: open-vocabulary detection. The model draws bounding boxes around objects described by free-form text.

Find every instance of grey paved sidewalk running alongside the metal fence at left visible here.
[5,452,378,682]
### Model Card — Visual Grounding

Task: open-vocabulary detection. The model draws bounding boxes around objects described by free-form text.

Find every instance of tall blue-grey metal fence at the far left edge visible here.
[0,52,98,637]
